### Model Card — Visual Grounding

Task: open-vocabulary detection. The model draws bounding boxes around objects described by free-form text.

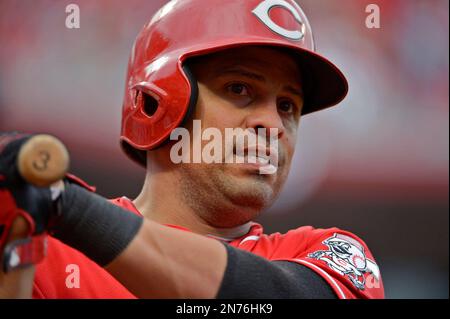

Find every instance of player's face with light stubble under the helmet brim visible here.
[160,47,303,227]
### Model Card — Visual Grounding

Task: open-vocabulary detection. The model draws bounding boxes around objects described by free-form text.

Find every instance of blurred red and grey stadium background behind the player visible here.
[0,0,449,298]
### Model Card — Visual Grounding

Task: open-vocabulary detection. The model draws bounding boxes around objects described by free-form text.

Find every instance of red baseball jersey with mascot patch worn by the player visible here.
[33,197,384,299]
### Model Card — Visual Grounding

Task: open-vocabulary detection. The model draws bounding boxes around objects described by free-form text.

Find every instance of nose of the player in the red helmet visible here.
[246,102,285,139]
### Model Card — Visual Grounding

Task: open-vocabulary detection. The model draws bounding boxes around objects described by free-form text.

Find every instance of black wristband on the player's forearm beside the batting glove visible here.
[51,182,143,266]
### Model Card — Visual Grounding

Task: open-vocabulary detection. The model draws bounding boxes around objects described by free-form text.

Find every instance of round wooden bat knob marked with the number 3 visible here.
[17,134,70,187]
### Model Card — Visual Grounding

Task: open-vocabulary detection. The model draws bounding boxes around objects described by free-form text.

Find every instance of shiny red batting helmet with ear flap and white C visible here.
[121,0,348,165]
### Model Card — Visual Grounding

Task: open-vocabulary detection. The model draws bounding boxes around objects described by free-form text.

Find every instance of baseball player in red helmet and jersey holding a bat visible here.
[0,0,384,299]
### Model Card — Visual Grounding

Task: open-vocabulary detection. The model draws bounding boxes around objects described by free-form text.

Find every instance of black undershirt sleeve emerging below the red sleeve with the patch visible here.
[216,244,337,299]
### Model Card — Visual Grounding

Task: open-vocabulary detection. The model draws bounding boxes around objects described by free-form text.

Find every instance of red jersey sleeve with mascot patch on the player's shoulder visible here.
[271,227,384,299]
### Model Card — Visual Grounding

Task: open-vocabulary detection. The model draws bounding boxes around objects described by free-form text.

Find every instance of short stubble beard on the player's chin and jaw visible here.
[180,164,277,228]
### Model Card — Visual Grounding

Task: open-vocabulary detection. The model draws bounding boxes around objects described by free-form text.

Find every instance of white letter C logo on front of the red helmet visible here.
[252,0,305,41]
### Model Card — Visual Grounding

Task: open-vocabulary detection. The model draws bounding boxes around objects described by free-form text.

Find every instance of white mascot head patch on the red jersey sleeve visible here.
[308,234,380,290]
